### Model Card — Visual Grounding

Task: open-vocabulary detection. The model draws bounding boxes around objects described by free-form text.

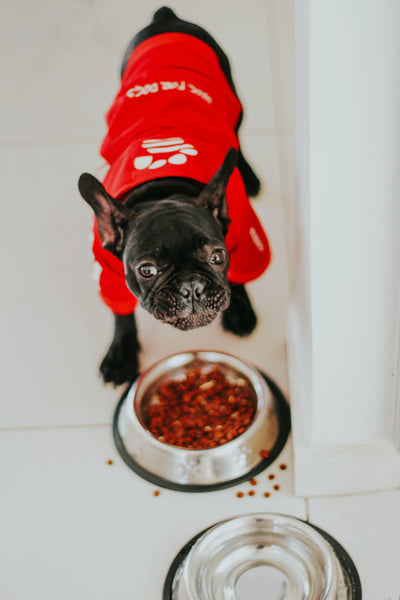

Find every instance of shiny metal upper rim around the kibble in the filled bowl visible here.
[131,350,266,457]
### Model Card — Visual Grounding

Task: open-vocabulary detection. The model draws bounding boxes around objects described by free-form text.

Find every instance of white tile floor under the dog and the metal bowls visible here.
[0,0,400,600]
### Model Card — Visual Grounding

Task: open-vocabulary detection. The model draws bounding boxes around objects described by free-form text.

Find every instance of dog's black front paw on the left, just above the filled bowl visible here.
[99,340,139,386]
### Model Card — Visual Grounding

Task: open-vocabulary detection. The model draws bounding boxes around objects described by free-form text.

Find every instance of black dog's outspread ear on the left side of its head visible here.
[78,173,135,258]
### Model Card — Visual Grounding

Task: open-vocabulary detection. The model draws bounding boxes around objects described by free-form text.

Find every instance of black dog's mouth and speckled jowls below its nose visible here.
[151,287,230,331]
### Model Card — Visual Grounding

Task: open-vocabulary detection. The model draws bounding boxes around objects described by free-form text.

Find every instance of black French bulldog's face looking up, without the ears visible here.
[123,197,229,329]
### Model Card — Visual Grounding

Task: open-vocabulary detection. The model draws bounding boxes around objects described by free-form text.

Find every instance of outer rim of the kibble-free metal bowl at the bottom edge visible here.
[162,513,362,600]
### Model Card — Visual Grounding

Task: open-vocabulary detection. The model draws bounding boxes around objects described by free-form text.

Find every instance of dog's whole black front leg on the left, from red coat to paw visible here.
[100,314,140,385]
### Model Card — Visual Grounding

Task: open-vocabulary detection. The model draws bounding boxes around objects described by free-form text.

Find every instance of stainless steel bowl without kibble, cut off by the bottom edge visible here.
[164,513,361,600]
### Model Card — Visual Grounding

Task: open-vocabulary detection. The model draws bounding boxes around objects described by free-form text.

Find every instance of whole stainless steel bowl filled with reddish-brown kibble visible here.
[113,350,290,492]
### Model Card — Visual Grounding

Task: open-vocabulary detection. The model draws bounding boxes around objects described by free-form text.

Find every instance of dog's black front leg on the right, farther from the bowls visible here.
[222,282,257,337]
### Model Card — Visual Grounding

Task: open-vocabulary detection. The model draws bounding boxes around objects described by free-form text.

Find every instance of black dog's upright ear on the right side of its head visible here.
[196,148,238,235]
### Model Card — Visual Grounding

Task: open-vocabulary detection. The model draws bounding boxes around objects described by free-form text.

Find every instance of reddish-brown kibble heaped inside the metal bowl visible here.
[143,366,256,450]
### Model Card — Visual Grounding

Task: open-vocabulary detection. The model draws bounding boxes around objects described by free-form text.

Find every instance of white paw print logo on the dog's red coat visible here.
[133,137,198,171]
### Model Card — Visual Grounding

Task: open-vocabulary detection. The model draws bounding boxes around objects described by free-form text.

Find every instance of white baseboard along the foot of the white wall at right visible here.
[287,304,400,497]
